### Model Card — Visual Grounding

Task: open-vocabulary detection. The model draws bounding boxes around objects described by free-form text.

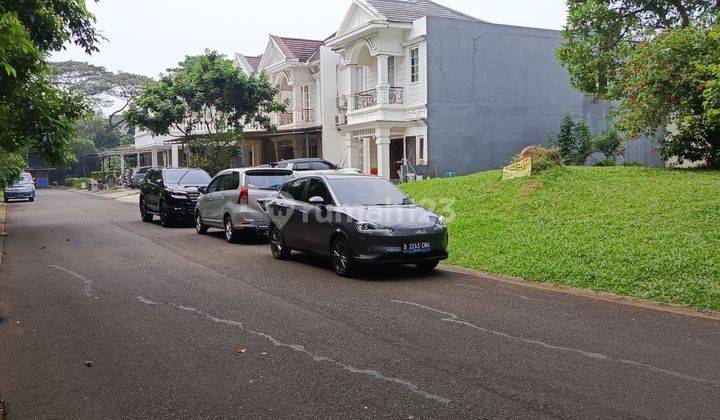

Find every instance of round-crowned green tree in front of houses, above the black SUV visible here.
[125,51,285,171]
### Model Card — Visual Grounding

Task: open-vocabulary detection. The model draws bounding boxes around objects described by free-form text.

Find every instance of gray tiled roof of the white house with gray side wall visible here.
[365,0,479,22]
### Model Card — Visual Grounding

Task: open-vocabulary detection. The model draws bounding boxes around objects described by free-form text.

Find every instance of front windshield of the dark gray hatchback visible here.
[328,177,411,206]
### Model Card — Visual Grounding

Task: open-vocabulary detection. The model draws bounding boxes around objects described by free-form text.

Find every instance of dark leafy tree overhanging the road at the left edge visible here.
[0,0,100,182]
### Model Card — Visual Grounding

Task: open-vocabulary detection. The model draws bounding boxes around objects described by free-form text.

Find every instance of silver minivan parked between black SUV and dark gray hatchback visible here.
[195,167,295,243]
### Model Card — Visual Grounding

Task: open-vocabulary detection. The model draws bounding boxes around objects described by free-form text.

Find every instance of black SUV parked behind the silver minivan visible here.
[140,168,212,227]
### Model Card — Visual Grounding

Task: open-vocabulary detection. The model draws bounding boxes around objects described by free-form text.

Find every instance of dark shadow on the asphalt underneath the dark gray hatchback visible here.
[290,252,444,282]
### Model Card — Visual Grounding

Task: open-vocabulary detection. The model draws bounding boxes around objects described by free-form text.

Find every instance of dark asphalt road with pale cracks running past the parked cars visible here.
[0,190,720,418]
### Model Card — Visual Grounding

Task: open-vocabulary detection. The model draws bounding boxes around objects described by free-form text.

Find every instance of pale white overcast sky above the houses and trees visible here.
[51,0,566,77]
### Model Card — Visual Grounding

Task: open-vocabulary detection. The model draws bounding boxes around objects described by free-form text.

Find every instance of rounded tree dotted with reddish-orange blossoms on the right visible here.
[617,24,720,168]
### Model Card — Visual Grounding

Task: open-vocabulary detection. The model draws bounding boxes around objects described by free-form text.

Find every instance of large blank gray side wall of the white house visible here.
[427,18,660,174]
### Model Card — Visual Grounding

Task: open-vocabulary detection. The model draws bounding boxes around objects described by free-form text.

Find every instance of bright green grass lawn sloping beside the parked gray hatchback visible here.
[402,167,720,310]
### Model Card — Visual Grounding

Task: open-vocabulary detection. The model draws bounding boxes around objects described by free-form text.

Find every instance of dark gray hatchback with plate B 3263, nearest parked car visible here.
[267,174,448,276]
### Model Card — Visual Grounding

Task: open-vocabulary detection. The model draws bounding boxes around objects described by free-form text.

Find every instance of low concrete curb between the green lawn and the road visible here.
[439,264,720,321]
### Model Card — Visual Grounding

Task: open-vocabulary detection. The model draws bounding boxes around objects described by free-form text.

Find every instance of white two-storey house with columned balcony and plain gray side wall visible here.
[322,0,656,179]
